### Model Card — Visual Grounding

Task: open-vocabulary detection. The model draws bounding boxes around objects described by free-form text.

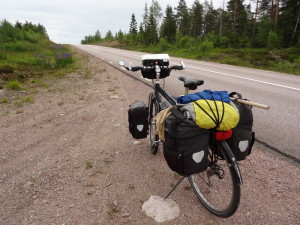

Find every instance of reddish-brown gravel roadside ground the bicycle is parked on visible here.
[0,48,300,225]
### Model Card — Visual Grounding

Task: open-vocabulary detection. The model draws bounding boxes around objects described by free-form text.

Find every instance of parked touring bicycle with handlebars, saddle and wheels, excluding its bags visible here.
[119,54,243,218]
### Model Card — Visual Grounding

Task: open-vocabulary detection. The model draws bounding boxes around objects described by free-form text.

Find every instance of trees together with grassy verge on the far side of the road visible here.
[81,0,300,75]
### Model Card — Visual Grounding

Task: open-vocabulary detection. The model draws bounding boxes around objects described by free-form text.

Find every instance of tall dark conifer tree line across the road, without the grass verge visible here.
[81,0,300,49]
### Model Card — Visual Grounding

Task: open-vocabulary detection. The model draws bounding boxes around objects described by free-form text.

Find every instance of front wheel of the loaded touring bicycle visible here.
[148,93,159,155]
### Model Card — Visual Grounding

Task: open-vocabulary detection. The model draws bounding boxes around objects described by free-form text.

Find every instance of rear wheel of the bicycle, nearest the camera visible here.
[188,144,241,218]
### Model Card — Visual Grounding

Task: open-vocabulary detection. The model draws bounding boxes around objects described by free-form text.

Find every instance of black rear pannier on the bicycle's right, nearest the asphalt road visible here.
[226,92,255,160]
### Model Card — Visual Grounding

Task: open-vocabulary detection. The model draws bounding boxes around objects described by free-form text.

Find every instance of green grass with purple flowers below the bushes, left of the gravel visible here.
[0,39,82,116]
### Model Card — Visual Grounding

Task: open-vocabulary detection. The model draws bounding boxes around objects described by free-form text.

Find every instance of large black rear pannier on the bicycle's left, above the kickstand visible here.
[163,109,210,176]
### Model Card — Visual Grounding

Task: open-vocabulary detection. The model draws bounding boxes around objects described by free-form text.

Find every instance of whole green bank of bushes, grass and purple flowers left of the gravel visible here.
[0,20,76,112]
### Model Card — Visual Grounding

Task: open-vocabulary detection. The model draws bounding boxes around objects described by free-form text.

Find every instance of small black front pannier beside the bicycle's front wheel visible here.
[128,101,148,139]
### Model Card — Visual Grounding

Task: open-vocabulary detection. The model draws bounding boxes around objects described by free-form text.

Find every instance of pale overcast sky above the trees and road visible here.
[0,0,248,44]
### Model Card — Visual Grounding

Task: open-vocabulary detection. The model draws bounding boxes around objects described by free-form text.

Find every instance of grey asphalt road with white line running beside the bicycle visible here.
[75,45,300,163]
